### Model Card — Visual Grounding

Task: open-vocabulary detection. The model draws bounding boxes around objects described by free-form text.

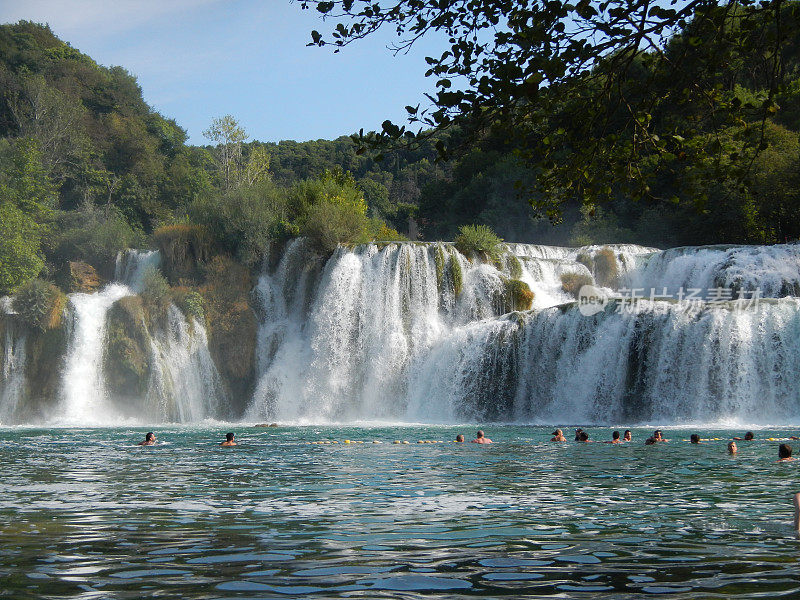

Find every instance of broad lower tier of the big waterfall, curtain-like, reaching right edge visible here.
[408,298,800,424]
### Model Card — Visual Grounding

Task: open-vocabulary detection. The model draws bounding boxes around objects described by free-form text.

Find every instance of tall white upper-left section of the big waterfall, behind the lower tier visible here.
[248,240,653,421]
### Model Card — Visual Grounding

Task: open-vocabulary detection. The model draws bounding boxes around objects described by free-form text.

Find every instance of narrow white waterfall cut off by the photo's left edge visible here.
[0,297,27,424]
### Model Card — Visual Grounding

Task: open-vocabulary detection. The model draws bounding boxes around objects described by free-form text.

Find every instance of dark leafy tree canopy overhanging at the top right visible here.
[300,0,800,220]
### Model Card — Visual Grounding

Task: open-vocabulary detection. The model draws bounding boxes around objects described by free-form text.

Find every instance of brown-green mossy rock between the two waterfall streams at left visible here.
[103,296,151,398]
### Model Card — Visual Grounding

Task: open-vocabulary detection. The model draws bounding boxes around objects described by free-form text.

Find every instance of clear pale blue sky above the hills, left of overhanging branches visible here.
[0,0,443,144]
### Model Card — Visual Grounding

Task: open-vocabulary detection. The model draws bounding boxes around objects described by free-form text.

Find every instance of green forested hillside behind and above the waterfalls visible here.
[0,14,800,294]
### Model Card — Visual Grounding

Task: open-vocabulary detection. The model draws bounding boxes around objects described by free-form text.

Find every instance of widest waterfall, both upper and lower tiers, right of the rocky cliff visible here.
[247,241,800,422]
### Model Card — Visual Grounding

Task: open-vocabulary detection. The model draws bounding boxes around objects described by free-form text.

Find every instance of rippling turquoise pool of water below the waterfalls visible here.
[0,426,800,599]
